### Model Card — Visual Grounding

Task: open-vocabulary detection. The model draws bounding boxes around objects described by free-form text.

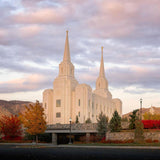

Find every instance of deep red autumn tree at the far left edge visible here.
[0,115,22,139]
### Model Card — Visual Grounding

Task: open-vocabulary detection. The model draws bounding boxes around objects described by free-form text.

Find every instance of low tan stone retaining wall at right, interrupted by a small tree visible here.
[106,131,160,141]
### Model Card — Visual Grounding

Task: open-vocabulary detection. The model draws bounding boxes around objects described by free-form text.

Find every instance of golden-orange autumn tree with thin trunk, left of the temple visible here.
[20,101,46,142]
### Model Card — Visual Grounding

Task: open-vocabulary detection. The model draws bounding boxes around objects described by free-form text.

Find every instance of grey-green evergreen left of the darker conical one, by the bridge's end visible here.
[97,112,108,137]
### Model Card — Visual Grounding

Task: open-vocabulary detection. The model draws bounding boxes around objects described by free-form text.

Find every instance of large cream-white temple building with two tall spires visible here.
[43,31,122,124]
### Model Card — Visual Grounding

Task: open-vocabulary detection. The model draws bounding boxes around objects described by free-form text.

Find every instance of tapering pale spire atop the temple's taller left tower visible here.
[63,30,70,61]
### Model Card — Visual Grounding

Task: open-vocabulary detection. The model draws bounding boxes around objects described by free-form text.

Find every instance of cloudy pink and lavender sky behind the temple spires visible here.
[0,0,160,113]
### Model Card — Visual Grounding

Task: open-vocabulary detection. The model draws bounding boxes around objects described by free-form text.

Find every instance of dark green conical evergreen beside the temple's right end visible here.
[109,111,121,132]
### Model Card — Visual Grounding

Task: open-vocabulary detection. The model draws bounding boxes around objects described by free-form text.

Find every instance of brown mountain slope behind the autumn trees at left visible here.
[0,100,33,118]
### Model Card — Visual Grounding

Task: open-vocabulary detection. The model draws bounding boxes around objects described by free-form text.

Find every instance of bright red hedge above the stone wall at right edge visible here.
[142,120,160,129]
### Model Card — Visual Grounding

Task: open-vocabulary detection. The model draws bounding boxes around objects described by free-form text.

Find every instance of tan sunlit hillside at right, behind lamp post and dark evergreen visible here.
[122,106,160,119]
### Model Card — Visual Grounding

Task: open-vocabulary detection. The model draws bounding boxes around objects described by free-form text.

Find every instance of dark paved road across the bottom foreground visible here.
[0,145,160,160]
